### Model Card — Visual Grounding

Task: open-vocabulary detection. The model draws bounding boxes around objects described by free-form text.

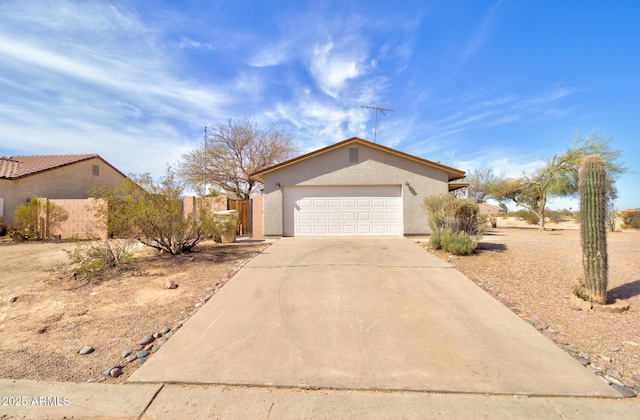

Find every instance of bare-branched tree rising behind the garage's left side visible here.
[177,117,298,200]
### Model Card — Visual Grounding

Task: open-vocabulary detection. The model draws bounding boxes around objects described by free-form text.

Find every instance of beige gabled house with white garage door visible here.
[251,137,468,236]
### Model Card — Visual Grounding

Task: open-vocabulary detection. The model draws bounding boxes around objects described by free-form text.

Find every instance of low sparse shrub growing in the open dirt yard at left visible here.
[64,239,135,278]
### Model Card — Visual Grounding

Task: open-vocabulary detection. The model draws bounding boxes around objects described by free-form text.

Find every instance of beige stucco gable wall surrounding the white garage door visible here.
[264,144,448,236]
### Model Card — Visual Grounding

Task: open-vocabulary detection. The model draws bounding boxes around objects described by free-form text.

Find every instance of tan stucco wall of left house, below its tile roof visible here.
[0,158,125,224]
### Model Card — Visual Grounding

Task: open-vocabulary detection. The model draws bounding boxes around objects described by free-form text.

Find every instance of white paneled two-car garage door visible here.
[284,185,403,236]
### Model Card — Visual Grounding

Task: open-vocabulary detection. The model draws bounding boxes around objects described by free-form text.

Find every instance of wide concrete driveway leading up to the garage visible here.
[128,238,620,397]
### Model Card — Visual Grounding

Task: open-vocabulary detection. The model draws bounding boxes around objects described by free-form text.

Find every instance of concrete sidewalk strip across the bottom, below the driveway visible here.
[0,380,640,420]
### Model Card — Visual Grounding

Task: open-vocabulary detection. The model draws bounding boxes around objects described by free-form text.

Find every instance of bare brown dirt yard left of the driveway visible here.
[0,241,268,383]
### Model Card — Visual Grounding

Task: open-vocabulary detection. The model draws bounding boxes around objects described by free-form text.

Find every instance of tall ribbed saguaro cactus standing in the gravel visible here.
[579,156,608,304]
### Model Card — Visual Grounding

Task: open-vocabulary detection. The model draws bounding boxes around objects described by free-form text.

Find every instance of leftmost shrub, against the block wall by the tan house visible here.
[9,197,69,241]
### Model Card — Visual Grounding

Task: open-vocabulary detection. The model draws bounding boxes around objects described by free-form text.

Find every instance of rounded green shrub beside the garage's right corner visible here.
[424,193,486,255]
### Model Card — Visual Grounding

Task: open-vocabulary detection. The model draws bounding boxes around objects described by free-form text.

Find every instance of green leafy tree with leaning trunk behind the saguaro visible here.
[495,130,626,230]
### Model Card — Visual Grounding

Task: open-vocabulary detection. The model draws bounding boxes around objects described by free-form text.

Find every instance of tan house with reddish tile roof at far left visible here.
[0,155,126,225]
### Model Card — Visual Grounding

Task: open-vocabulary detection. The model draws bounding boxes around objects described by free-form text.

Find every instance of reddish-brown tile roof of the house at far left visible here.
[0,154,102,179]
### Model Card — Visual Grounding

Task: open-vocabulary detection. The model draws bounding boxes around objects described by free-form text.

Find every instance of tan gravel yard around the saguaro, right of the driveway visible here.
[423,228,640,390]
